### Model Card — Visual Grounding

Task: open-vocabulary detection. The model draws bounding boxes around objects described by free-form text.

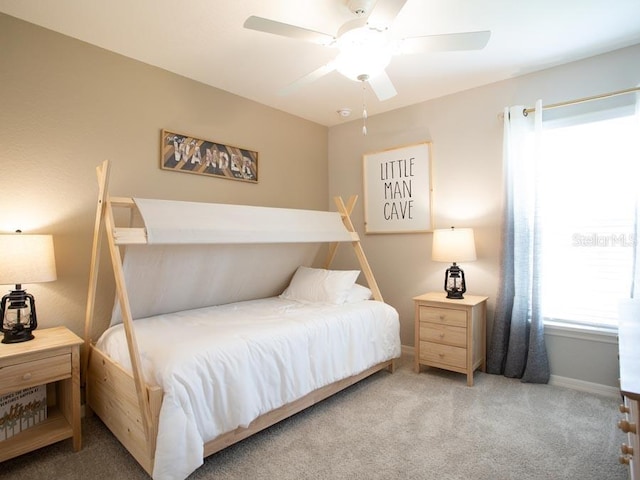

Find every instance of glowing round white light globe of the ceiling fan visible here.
[335,26,393,81]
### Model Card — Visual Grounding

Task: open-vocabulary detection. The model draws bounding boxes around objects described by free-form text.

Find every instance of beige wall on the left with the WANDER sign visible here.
[0,14,328,342]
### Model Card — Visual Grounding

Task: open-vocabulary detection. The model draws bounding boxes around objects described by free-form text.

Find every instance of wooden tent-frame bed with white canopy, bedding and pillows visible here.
[83,161,400,480]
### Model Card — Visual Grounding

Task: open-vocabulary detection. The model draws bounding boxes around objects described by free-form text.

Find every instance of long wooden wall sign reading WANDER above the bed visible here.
[160,130,258,183]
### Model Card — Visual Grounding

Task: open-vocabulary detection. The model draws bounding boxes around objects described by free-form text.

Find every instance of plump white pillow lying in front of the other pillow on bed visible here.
[280,266,360,305]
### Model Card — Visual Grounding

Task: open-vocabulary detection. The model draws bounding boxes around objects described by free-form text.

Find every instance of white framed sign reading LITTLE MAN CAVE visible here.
[363,142,433,233]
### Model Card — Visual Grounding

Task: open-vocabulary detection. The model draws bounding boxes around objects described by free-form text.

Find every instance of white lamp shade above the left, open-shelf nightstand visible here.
[0,233,57,285]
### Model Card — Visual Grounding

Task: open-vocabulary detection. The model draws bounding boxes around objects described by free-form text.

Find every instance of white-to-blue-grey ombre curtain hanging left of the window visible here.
[487,101,549,383]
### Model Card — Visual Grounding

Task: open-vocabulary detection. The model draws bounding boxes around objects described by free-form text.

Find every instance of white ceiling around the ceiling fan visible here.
[0,0,640,126]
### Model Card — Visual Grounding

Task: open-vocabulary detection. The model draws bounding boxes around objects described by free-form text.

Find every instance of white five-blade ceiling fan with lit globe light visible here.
[244,0,491,101]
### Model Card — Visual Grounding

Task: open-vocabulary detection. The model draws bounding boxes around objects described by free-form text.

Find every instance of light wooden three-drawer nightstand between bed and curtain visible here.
[413,292,489,386]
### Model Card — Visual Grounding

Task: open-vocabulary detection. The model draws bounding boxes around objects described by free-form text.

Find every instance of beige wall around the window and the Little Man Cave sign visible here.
[329,45,640,386]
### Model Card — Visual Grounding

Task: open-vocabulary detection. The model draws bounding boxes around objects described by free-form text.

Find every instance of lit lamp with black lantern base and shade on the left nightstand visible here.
[0,230,56,343]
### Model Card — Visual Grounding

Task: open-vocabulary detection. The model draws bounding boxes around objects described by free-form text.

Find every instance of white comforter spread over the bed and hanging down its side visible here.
[97,296,400,480]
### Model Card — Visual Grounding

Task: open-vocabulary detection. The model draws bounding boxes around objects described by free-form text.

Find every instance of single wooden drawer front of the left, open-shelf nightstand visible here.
[0,354,71,393]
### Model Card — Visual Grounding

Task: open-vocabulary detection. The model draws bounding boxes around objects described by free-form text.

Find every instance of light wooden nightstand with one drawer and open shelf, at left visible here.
[0,327,83,462]
